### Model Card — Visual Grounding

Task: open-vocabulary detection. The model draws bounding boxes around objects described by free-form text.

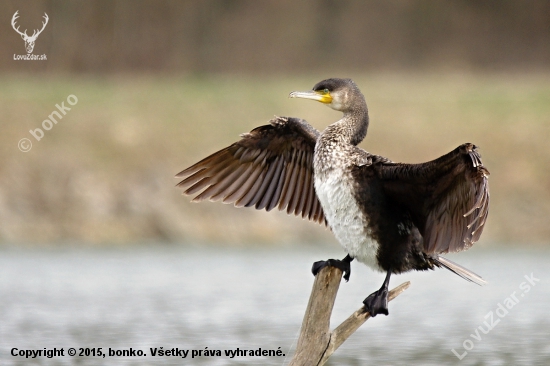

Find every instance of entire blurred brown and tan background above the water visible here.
[0,0,550,245]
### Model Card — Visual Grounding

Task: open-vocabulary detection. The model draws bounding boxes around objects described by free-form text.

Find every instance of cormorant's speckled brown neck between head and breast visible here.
[326,106,369,145]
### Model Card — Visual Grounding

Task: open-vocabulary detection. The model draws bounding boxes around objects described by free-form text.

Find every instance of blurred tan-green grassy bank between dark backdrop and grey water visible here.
[0,73,550,243]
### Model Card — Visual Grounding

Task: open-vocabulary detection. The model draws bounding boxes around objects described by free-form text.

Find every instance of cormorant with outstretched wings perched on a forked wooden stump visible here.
[176,78,489,317]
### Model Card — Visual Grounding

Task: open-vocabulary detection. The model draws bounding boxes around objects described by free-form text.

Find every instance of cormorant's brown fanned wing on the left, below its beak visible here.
[176,117,325,223]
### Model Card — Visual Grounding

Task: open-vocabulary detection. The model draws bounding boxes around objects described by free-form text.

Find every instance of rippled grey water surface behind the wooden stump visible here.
[0,245,550,365]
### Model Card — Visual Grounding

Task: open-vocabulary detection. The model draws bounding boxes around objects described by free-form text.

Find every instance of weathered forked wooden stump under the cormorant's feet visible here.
[289,266,411,366]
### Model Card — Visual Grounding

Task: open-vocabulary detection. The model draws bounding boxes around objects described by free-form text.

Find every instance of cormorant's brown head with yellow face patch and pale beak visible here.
[289,78,366,113]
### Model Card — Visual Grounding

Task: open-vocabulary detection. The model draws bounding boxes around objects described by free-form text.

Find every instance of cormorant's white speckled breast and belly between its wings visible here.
[315,169,382,271]
